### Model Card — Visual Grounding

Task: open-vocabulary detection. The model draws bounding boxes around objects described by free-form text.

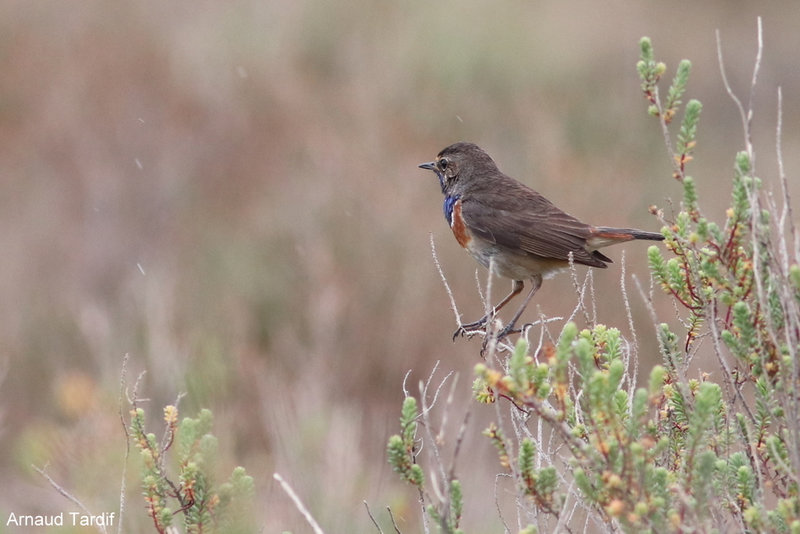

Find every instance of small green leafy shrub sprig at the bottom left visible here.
[128,405,256,533]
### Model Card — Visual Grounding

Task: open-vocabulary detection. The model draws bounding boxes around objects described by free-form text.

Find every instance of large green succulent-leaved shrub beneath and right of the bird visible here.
[390,33,800,533]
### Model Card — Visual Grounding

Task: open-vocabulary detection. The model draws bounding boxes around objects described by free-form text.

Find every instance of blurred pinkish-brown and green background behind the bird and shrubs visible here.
[0,0,800,533]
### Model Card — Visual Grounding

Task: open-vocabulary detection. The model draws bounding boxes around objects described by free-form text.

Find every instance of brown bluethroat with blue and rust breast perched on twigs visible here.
[420,142,664,339]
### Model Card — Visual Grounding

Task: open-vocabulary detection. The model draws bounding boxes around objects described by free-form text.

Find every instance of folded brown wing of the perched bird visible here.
[461,182,611,267]
